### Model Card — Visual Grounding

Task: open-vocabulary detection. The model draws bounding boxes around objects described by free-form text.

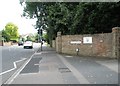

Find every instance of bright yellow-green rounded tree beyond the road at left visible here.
[3,23,19,41]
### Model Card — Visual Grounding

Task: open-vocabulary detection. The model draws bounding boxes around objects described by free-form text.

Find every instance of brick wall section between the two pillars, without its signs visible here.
[62,33,112,57]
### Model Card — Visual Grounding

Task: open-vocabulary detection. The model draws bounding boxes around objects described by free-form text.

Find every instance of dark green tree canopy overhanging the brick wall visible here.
[21,2,120,44]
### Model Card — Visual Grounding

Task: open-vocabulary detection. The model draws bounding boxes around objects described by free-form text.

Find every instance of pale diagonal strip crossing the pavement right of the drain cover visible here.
[58,54,89,84]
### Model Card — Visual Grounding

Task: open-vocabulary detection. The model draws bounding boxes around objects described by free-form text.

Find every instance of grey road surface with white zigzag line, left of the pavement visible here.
[0,43,40,83]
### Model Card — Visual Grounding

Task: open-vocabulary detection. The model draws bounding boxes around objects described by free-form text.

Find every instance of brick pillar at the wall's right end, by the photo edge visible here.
[112,27,120,58]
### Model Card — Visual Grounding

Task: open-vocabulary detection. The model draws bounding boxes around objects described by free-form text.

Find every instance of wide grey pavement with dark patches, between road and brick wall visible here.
[5,45,118,84]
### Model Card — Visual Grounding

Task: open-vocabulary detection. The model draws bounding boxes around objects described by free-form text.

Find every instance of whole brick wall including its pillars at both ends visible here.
[56,27,120,58]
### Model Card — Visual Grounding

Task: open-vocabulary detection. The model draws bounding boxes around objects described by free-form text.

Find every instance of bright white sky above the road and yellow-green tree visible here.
[0,0,37,35]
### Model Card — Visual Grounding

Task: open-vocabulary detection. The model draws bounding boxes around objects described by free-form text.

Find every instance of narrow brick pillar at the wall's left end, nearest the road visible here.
[56,32,62,53]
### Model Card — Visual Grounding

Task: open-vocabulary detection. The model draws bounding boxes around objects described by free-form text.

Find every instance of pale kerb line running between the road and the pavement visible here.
[4,53,35,84]
